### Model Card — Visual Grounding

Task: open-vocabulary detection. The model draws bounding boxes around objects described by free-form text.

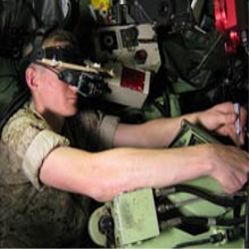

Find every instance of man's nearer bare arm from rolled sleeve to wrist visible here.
[40,146,209,201]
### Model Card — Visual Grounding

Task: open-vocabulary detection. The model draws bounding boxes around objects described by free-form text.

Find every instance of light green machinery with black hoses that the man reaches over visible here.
[89,121,248,248]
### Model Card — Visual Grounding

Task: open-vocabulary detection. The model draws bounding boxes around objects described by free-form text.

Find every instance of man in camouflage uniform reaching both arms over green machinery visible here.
[0,30,249,247]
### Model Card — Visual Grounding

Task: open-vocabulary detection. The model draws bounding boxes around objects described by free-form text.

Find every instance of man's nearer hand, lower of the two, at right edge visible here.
[207,144,249,193]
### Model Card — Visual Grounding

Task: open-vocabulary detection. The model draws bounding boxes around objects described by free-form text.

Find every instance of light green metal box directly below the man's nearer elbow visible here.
[112,188,159,247]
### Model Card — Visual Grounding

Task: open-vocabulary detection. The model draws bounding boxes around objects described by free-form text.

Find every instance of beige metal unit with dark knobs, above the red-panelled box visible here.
[95,23,161,72]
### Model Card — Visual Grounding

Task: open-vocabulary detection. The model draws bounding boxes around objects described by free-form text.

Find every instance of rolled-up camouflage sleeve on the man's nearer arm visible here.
[2,114,69,189]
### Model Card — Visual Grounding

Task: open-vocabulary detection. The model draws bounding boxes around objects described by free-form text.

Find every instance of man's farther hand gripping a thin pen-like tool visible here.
[198,102,247,144]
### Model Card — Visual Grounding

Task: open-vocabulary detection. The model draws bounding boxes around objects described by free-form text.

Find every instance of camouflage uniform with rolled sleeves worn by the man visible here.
[0,99,118,247]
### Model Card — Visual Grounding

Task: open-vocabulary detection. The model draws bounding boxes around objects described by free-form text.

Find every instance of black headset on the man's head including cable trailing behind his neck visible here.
[0,27,110,133]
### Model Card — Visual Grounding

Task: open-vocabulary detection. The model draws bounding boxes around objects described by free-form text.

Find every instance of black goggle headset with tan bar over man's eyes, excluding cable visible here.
[24,46,110,98]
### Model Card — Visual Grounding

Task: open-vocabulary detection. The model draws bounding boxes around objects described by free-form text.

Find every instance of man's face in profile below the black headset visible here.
[36,67,78,117]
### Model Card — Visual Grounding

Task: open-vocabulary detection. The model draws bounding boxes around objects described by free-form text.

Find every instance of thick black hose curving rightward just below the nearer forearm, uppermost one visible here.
[160,184,245,207]
